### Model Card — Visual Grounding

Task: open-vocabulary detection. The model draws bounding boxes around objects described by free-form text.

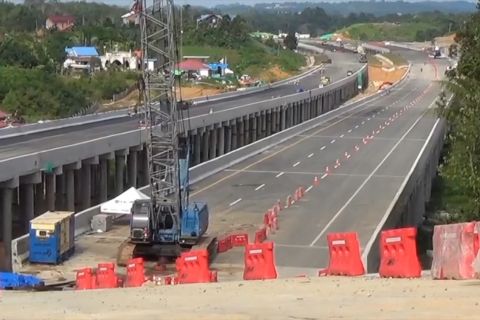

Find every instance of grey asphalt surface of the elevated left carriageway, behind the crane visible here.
[0,53,361,160]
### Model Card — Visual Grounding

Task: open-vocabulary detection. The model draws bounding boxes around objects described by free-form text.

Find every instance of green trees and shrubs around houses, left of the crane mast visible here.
[0,0,139,120]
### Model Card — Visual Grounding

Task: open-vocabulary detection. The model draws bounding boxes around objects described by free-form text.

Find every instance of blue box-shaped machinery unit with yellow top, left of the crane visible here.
[29,211,75,264]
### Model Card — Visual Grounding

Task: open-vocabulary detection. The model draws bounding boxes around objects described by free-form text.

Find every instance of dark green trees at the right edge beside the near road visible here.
[439,5,480,220]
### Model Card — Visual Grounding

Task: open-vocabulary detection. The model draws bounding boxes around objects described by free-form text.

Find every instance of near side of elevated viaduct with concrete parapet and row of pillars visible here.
[0,66,368,266]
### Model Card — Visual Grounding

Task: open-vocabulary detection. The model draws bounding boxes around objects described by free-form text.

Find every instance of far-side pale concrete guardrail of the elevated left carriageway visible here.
[0,43,321,139]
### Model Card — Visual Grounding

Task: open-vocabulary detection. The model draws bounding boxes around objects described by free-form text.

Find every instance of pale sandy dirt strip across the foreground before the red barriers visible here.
[0,277,480,320]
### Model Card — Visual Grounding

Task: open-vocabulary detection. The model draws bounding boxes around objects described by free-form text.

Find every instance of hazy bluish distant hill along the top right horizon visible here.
[215,1,475,16]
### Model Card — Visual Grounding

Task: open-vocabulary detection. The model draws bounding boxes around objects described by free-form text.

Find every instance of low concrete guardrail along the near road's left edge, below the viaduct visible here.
[11,62,404,272]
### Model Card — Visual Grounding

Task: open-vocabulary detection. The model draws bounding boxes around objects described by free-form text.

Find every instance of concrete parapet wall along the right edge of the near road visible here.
[362,119,446,273]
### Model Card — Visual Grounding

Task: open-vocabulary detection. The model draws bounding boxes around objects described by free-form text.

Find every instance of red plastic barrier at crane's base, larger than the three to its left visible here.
[175,249,216,283]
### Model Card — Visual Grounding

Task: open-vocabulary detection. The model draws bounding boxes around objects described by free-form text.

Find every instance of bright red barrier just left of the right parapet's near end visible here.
[322,232,365,276]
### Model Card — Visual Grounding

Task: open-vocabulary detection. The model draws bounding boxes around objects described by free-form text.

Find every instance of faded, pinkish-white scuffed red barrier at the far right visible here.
[431,222,479,279]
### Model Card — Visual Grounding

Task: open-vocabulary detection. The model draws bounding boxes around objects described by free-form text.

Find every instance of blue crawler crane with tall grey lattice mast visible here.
[117,0,216,265]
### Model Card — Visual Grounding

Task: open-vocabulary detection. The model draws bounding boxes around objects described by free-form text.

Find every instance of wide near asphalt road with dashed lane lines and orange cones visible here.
[192,53,441,269]
